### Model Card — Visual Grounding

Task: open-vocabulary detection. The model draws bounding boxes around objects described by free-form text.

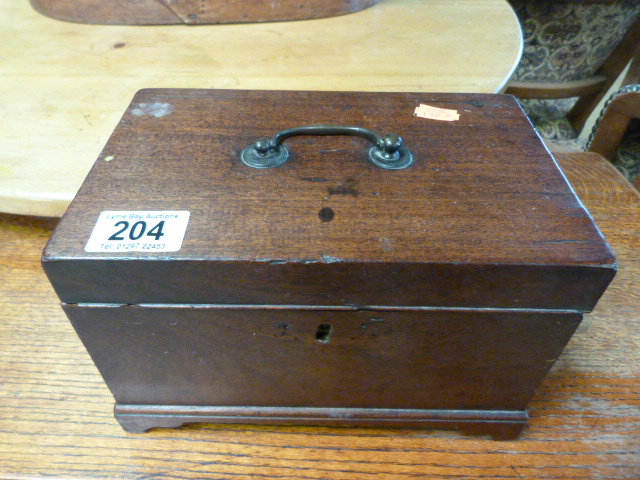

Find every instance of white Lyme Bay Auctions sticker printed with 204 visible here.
[84,210,189,253]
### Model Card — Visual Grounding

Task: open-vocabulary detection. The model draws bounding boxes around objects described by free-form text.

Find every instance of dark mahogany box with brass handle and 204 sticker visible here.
[43,89,616,438]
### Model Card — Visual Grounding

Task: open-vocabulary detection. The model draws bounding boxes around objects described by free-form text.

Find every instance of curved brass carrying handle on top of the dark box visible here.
[240,125,413,170]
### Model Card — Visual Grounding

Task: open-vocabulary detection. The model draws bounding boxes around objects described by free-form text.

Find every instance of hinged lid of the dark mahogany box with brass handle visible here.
[43,89,616,311]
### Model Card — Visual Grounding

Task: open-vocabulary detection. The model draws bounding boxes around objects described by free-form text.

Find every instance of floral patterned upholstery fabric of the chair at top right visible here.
[510,0,640,143]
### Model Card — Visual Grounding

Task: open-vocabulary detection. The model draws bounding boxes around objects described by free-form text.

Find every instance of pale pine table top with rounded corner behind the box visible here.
[0,0,522,216]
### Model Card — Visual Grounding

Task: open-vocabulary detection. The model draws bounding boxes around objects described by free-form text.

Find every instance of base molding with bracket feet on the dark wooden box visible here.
[114,404,529,440]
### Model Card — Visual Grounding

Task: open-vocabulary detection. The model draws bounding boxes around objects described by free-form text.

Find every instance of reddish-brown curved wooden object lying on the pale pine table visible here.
[31,0,380,25]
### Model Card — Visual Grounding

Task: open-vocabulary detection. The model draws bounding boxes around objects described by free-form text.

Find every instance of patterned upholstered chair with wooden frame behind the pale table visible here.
[507,0,640,142]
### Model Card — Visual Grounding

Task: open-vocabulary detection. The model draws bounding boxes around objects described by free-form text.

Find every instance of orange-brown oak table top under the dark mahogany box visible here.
[0,153,640,480]
